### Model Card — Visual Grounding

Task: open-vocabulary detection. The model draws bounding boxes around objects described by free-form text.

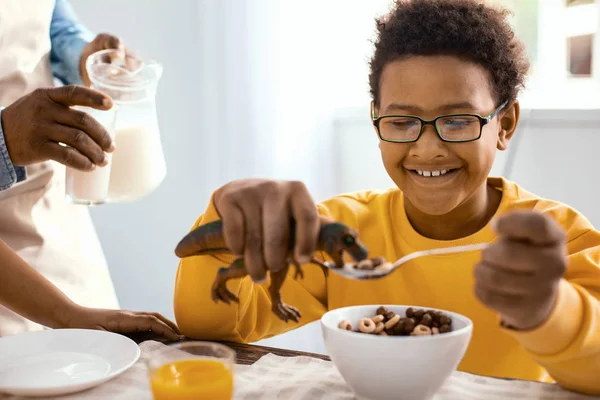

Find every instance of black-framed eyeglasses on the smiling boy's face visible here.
[371,101,508,143]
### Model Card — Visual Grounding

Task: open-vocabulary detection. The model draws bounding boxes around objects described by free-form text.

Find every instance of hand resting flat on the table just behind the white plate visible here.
[65,306,182,340]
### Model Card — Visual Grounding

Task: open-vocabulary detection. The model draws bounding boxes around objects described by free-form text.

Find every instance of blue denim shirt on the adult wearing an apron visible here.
[0,0,95,190]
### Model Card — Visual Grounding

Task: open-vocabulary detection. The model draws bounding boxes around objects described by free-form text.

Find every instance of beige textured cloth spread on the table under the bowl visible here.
[0,341,600,400]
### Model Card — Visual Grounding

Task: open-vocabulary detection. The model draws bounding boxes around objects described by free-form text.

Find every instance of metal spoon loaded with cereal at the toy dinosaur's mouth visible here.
[323,243,488,280]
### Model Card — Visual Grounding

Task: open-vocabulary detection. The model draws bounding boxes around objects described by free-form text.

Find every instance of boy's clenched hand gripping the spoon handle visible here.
[474,211,567,330]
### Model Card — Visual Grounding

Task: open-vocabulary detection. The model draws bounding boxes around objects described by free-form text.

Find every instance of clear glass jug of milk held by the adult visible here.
[86,50,167,202]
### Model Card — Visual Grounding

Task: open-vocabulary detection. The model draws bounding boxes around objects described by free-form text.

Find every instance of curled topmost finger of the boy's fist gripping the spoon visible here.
[495,211,565,246]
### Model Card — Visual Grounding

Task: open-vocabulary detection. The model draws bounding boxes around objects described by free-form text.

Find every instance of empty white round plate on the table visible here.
[0,329,140,396]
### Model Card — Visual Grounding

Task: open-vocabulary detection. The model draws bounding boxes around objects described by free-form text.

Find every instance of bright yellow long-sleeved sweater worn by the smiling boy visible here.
[174,178,600,394]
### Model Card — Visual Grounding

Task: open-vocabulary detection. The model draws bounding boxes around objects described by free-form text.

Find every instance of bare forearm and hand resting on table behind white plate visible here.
[0,240,181,340]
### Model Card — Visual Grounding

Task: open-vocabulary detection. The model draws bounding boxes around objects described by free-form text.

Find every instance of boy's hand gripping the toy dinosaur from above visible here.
[180,179,319,282]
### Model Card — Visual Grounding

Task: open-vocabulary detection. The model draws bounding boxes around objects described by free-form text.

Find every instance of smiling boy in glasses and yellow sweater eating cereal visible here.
[175,0,600,394]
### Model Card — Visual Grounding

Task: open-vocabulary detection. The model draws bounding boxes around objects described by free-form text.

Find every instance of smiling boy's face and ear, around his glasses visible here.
[375,56,518,215]
